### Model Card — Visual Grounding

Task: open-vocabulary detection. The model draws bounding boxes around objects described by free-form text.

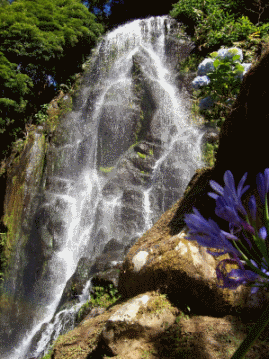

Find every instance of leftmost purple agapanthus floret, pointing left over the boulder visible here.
[185,208,240,257]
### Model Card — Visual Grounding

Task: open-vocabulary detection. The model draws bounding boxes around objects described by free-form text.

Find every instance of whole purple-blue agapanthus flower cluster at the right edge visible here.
[185,168,269,293]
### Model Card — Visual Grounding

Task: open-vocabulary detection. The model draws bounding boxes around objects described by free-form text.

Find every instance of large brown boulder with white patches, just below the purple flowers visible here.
[118,228,269,317]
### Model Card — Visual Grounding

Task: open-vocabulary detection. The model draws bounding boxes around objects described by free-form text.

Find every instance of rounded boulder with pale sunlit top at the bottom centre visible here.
[101,294,178,358]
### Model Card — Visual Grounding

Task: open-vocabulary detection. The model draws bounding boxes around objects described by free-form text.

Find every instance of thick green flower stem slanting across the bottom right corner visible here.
[231,305,269,359]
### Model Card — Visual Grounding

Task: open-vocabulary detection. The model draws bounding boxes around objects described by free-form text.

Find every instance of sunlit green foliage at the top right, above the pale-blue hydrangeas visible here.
[170,0,264,51]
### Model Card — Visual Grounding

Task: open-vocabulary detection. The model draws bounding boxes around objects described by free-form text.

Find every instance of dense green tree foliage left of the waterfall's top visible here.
[0,0,103,158]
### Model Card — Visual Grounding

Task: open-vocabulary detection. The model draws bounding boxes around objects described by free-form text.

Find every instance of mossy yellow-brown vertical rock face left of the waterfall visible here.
[0,127,46,346]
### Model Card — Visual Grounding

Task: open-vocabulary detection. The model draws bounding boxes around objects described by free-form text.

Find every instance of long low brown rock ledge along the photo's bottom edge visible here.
[51,291,269,359]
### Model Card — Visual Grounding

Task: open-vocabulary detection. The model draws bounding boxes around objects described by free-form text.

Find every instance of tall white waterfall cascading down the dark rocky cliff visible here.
[1,17,202,359]
